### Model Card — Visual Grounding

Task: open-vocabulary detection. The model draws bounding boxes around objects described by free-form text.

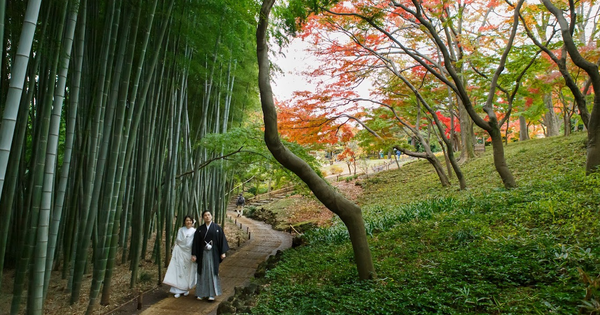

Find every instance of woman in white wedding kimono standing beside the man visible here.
[163,215,198,298]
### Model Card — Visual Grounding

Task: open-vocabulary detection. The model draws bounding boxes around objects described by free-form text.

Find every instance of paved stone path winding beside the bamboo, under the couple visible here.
[112,209,292,315]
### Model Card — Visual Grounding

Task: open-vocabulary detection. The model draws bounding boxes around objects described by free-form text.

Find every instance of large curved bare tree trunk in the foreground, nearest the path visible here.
[256,0,375,279]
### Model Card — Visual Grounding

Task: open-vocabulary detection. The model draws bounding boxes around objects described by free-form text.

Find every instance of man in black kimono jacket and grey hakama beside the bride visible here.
[192,210,229,302]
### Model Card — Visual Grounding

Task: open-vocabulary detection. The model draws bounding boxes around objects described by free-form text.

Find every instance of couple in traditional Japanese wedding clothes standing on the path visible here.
[163,210,229,301]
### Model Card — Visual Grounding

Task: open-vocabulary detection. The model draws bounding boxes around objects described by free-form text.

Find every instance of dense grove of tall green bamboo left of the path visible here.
[0,0,258,314]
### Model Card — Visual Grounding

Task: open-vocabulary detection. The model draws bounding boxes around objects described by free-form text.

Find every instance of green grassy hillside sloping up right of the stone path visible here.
[252,134,600,314]
